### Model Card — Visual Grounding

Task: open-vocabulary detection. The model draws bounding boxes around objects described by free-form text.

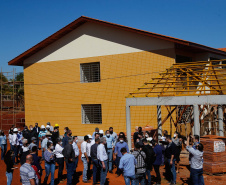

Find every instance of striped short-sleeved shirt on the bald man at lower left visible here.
[20,163,38,185]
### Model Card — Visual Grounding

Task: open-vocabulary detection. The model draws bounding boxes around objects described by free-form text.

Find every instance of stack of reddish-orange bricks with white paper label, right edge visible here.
[200,135,226,174]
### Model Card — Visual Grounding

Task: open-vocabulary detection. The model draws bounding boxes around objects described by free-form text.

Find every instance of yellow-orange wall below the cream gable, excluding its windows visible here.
[24,49,175,136]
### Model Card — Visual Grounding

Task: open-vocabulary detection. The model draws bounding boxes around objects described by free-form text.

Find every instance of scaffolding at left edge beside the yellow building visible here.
[0,69,25,130]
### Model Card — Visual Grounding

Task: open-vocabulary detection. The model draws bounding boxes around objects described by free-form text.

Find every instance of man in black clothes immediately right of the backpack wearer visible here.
[143,139,155,185]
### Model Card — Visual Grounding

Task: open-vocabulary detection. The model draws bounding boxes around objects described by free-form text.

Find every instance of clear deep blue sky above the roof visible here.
[0,0,226,72]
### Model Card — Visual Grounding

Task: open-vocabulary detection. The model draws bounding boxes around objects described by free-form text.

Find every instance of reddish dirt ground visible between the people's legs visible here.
[0,143,226,185]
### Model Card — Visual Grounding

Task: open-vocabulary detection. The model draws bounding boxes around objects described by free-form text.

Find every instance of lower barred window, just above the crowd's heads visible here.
[82,104,102,124]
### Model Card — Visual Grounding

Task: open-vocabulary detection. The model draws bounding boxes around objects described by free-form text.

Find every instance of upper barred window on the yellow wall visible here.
[80,62,100,83]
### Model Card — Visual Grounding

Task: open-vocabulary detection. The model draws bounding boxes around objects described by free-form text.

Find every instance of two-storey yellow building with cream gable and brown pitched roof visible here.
[9,16,226,136]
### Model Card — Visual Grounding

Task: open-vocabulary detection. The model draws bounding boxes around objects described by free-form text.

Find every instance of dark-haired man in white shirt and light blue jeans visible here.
[81,136,89,183]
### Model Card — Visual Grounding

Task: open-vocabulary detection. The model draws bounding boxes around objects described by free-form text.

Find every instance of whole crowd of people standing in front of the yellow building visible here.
[0,122,204,185]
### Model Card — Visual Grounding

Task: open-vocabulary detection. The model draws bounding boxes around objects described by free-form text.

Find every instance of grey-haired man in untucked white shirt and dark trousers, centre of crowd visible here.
[97,137,108,185]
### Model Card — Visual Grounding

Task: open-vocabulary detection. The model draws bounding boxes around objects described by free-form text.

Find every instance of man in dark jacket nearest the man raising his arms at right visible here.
[165,135,179,184]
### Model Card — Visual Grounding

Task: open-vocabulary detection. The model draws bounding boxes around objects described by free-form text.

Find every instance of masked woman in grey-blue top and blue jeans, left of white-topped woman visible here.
[44,142,55,185]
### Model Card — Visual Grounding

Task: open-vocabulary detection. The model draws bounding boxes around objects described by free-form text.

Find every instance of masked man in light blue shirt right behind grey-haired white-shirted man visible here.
[104,130,115,173]
